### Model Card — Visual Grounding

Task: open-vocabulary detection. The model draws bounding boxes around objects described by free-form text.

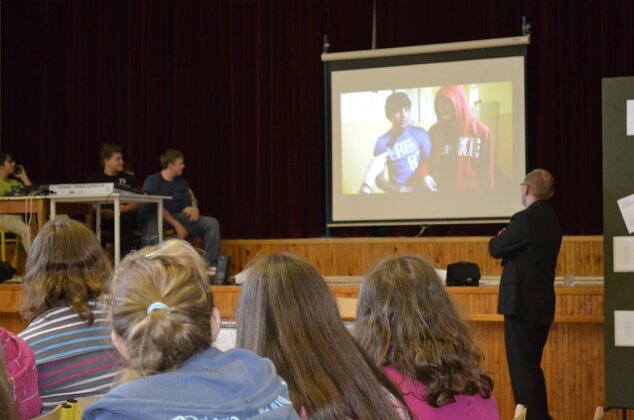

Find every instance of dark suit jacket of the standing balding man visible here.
[489,200,562,324]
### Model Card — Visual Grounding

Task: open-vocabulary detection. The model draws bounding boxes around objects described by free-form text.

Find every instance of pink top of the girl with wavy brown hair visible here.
[384,367,500,420]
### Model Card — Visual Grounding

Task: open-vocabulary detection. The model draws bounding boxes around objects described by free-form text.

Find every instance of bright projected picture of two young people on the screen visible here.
[340,81,513,195]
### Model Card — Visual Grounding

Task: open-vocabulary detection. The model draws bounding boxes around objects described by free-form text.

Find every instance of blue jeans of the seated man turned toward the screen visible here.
[139,213,220,266]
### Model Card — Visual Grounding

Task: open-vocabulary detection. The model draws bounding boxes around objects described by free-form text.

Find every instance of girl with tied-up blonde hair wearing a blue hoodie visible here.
[83,240,298,419]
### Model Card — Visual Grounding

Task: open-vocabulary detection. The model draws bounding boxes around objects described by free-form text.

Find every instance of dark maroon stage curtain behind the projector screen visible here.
[0,0,634,238]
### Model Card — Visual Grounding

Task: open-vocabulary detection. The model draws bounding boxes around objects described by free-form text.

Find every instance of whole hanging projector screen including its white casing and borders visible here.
[322,37,528,226]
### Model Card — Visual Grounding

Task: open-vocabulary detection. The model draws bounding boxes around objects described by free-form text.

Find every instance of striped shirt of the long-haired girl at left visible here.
[19,302,120,411]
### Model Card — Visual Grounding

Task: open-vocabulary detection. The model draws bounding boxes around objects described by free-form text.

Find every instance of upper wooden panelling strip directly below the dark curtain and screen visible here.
[222,236,603,277]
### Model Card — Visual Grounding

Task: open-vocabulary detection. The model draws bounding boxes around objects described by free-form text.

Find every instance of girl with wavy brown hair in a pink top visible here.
[353,257,500,420]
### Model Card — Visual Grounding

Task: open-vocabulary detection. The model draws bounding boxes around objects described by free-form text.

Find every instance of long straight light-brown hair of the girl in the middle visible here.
[237,253,409,420]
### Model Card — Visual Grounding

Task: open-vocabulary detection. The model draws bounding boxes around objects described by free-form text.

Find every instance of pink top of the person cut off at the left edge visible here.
[0,328,42,419]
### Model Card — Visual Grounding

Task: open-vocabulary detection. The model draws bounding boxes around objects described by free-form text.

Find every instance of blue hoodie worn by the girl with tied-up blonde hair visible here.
[82,347,299,420]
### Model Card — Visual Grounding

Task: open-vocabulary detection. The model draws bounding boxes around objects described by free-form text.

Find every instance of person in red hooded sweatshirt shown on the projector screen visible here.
[421,85,495,191]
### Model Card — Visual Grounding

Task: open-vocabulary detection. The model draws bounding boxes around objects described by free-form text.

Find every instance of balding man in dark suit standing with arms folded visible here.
[489,169,562,420]
